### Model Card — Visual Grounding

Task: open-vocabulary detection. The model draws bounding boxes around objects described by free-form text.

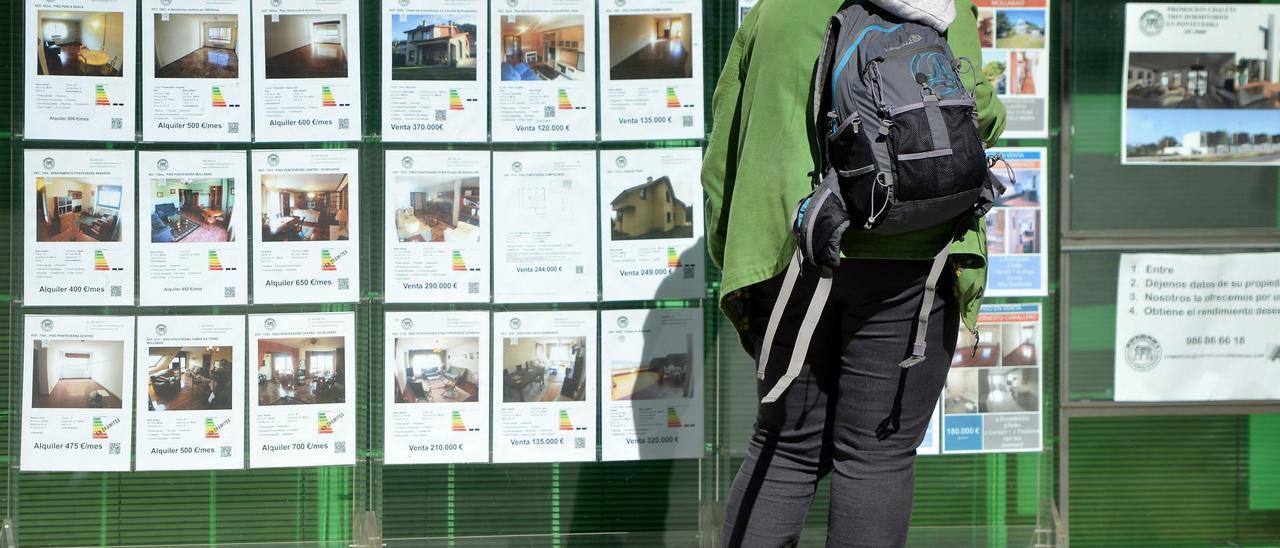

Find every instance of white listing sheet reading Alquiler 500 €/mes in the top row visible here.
[141,0,253,142]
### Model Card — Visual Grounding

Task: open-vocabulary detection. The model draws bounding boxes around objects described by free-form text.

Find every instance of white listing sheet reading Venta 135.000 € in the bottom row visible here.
[493,311,598,462]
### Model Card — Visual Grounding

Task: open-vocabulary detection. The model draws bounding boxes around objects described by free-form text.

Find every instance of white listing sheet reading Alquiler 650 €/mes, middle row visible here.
[253,149,360,303]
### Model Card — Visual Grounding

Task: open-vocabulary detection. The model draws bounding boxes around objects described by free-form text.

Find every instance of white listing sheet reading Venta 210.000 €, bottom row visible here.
[383,311,492,465]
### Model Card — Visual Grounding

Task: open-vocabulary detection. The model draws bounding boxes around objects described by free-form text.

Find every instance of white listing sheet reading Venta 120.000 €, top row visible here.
[489,0,595,142]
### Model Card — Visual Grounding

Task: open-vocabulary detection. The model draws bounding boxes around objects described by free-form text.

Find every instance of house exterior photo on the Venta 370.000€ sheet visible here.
[392,14,476,82]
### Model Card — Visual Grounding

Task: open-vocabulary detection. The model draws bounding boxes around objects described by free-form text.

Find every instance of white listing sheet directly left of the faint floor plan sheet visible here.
[383,150,493,302]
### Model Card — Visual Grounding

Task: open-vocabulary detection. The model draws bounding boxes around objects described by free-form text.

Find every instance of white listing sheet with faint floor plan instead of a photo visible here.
[493,150,596,302]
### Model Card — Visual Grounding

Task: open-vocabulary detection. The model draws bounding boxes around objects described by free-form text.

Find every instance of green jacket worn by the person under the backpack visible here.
[701,0,1005,351]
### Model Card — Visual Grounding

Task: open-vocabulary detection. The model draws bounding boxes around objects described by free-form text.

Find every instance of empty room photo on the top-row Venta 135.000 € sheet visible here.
[609,13,694,79]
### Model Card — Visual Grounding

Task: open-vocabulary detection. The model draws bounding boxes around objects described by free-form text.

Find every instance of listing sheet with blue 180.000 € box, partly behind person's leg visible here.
[942,302,1044,453]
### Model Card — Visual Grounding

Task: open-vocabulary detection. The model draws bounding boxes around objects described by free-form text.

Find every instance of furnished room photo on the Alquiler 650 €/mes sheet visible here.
[261,173,351,242]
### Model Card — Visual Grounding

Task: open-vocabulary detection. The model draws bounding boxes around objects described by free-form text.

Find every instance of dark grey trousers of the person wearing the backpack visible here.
[722,259,960,548]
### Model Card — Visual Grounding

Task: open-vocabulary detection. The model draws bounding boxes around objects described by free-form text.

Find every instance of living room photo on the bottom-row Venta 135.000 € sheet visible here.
[502,337,589,403]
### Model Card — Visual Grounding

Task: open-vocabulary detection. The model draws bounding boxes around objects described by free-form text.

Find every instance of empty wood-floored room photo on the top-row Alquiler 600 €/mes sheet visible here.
[262,14,347,78]
